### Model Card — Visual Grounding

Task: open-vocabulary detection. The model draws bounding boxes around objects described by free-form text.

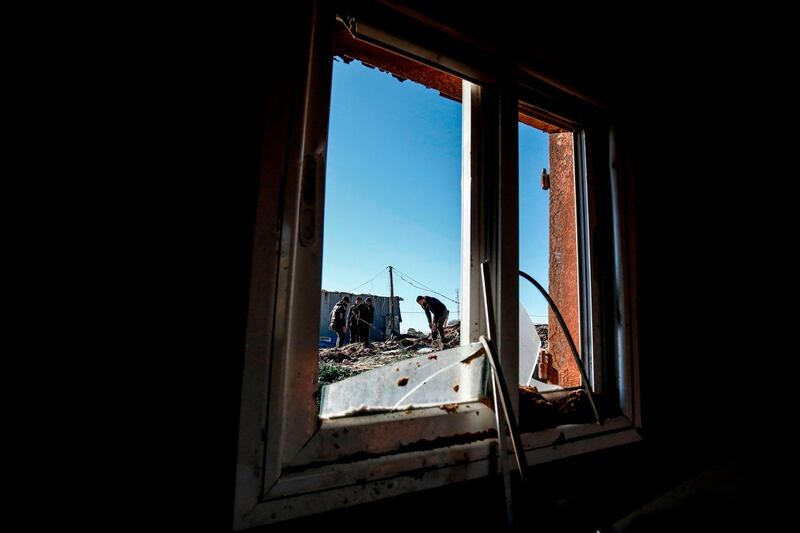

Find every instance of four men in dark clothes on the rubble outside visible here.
[328,290,450,348]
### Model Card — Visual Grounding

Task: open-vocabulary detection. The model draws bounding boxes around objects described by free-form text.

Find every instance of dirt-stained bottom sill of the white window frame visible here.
[242,412,641,529]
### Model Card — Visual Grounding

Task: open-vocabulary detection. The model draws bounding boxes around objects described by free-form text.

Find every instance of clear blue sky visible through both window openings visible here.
[322,61,548,333]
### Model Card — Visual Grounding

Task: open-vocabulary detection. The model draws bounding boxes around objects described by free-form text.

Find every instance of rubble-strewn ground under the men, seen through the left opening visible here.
[319,322,461,377]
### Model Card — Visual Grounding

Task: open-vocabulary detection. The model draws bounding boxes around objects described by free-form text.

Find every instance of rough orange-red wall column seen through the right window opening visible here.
[544,132,581,387]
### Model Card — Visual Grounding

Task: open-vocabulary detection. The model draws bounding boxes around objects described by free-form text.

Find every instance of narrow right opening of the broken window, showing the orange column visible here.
[519,112,593,431]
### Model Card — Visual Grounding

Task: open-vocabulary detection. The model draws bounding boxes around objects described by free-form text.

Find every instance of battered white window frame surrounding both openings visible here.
[234,1,639,530]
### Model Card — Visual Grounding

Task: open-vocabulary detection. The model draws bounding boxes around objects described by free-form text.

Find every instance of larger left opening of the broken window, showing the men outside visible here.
[319,38,488,419]
